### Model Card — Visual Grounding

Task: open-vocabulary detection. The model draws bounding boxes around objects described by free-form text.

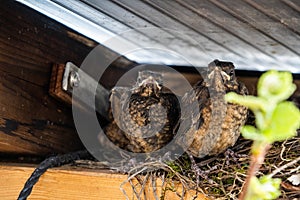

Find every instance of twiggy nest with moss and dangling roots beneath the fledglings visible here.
[109,135,300,199]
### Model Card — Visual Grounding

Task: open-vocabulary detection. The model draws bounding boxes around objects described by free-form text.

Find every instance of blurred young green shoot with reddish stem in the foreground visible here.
[225,70,300,200]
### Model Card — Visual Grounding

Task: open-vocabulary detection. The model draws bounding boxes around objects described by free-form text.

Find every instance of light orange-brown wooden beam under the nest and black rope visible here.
[0,163,207,200]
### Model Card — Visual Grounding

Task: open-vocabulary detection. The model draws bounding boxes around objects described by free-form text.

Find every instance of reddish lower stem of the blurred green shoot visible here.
[239,144,271,200]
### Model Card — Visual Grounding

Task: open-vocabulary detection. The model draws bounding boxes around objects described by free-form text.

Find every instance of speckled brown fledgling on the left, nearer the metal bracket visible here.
[105,71,180,153]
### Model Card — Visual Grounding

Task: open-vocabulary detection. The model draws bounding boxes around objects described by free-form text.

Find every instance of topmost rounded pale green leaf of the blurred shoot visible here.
[257,70,296,102]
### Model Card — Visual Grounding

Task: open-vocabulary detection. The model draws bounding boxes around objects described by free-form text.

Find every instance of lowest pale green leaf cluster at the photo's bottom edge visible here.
[245,176,281,200]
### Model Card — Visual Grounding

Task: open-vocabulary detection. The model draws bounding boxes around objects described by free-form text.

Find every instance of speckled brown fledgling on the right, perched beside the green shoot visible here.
[181,60,248,158]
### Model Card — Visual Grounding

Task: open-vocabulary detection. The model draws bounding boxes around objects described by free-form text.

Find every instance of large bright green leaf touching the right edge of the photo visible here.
[262,101,300,143]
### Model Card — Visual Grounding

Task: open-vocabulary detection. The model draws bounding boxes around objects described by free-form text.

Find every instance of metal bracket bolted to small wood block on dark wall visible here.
[49,62,110,119]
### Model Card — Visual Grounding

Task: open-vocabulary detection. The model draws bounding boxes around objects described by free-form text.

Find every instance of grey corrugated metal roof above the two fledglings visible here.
[18,0,300,73]
